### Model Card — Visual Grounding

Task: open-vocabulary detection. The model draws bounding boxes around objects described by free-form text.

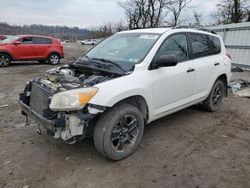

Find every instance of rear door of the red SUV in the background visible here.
[33,37,52,59]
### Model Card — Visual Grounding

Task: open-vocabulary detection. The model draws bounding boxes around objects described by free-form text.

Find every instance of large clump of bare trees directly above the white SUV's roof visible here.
[118,0,192,29]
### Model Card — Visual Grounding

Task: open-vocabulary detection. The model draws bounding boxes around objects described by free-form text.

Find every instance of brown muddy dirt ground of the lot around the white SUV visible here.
[0,44,250,188]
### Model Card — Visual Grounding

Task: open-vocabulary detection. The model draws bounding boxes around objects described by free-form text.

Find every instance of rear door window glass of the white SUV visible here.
[188,33,211,58]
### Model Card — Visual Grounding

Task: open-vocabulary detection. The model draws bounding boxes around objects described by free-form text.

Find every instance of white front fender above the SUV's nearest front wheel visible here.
[89,71,153,117]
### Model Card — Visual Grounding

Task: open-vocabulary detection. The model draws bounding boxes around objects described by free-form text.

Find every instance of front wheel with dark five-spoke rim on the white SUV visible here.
[94,104,144,161]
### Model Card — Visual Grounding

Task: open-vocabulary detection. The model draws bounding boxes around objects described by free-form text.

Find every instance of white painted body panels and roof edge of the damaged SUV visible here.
[89,28,231,122]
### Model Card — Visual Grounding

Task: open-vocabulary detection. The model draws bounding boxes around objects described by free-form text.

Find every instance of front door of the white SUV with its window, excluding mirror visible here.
[151,33,195,117]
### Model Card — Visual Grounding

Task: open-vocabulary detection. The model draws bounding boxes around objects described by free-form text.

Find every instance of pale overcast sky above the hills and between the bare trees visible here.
[0,0,220,28]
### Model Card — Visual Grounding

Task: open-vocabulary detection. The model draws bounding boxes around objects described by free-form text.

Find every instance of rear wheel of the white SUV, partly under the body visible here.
[203,80,225,112]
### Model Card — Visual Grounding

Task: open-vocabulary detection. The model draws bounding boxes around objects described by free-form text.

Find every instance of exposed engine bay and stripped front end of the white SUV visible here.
[20,64,125,144]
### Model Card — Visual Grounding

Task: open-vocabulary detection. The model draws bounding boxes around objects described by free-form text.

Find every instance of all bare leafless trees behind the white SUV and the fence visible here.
[118,0,250,29]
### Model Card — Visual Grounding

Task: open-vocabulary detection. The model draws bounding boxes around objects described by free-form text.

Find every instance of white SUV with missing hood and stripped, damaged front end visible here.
[20,28,231,160]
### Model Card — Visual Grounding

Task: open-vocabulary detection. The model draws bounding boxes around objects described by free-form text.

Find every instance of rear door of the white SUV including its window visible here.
[188,33,215,95]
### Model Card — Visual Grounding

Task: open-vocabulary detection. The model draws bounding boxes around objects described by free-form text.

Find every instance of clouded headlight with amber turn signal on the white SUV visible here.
[50,87,98,111]
